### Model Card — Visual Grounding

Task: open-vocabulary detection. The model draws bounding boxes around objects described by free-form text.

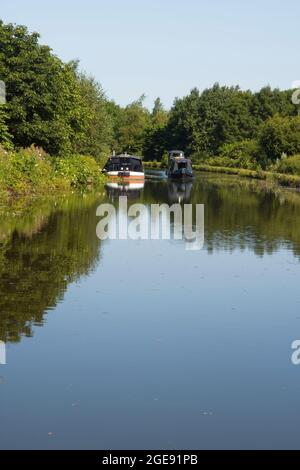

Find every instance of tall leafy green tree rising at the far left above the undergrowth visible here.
[0,21,88,154]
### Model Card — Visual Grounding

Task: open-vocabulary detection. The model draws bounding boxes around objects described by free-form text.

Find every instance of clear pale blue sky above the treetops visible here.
[0,0,300,107]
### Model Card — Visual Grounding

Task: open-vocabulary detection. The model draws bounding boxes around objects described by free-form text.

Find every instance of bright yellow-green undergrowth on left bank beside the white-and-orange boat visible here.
[0,146,104,200]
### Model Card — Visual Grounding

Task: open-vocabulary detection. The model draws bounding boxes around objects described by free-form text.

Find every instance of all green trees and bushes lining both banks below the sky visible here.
[0,17,300,196]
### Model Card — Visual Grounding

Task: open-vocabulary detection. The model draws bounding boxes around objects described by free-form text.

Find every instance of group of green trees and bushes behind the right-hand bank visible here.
[145,83,300,168]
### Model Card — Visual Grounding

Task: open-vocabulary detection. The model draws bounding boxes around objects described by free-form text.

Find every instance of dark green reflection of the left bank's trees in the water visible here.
[0,195,100,342]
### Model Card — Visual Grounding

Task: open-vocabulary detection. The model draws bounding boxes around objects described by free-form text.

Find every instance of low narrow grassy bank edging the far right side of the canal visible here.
[143,161,300,188]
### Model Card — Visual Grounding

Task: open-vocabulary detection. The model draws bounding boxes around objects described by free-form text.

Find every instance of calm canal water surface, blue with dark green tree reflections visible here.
[0,175,300,449]
